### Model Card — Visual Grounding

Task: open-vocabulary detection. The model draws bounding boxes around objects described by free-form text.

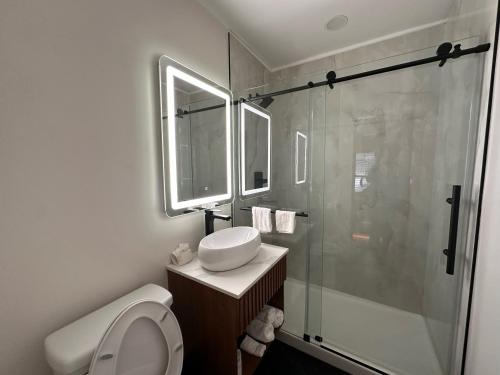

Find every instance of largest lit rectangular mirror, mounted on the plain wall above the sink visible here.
[159,56,233,216]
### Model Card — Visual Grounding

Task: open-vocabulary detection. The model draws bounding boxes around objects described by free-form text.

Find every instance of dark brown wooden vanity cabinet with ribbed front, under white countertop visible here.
[168,256,286,375]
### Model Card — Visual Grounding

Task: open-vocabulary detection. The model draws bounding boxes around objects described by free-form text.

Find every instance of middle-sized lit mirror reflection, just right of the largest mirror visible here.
[240,102,271,196]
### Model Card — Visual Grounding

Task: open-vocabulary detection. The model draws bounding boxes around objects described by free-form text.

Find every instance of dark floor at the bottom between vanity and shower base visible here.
[254,341,348,375]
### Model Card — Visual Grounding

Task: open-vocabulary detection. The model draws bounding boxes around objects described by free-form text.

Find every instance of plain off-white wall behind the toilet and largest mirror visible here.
[0,0,228,375]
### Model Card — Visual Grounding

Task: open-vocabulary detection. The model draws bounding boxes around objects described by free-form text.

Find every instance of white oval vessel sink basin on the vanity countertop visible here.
[198,227,260,271]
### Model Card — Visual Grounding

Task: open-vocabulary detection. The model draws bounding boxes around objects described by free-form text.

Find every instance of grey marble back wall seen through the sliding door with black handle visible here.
[322,64,437,313]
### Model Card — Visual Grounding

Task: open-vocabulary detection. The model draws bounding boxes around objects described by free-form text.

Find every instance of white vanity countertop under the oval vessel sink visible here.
[167,243,288,299]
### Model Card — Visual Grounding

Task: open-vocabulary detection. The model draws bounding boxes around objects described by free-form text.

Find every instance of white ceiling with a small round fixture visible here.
[198,0,454,70]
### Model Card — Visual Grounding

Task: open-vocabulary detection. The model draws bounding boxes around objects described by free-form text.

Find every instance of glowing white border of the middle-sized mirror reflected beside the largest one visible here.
[240,102,271,197]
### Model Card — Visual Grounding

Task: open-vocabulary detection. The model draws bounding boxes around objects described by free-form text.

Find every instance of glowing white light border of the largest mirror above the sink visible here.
[160,56,233,216]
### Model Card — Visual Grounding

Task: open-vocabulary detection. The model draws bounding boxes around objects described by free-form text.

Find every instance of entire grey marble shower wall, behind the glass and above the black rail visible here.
[231,18,488,314]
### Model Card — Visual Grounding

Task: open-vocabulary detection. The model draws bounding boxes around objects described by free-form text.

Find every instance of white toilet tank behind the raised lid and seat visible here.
[45,284,172,375]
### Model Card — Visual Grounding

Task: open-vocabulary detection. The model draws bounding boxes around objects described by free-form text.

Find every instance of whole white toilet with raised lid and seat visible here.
[45,284,184,375]
